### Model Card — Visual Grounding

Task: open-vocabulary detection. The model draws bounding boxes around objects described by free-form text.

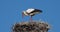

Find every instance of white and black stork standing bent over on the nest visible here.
[22,8,42,21]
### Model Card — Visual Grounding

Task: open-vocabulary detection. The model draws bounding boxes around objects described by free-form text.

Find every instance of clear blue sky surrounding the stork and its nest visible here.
[0,0,60,32]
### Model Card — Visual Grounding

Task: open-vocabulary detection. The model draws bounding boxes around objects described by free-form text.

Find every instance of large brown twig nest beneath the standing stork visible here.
[13,22,50,32]
